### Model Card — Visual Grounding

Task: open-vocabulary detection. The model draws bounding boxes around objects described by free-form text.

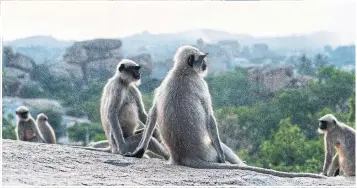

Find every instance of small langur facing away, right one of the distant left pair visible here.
[36,113,56,144]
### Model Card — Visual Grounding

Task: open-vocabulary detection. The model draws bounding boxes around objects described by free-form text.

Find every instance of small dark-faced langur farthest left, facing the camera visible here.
[15,106,46,142]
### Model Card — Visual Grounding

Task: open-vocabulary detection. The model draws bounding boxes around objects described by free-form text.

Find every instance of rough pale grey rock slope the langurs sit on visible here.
[2,140,356,186]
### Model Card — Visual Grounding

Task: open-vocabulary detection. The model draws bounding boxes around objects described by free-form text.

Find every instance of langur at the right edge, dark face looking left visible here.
[318,114,356,176]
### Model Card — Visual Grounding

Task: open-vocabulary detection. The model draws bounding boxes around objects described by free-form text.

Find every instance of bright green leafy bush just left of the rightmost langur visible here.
[260,118,323,172]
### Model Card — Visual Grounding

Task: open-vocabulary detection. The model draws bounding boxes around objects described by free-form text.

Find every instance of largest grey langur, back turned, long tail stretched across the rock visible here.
[127,45,323,178]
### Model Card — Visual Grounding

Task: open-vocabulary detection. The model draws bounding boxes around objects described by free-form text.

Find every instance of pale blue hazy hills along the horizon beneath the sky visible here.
[4,29,354,63]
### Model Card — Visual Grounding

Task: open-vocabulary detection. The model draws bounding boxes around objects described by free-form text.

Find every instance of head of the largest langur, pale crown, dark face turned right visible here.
[174,45,208,77]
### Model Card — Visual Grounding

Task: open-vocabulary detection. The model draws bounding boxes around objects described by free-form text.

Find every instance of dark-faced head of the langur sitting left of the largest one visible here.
[117,59,141,85]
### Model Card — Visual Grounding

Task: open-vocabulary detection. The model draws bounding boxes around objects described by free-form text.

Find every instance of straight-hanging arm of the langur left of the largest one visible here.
[107,92,126,154]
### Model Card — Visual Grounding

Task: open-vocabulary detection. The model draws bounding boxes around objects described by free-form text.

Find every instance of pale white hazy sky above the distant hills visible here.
[1,0,356,42]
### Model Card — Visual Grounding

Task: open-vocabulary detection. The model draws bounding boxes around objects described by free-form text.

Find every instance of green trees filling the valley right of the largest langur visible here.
[211,66,355,172]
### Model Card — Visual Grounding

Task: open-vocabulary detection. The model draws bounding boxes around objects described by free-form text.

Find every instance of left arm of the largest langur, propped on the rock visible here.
[126,104,157,158]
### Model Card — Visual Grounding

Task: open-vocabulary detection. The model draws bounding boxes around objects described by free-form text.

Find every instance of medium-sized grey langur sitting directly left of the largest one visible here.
[74,59,169,159]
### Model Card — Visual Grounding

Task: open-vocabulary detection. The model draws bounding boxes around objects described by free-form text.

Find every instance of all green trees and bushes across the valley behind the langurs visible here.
[2,45,355,173]
